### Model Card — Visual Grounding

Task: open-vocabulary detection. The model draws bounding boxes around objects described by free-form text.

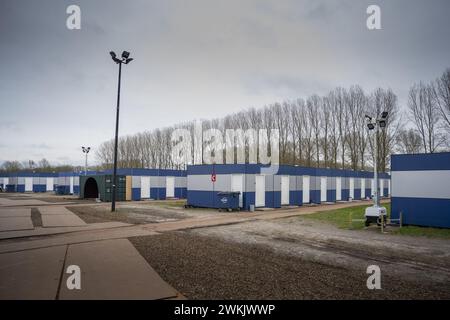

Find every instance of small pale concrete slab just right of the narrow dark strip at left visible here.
[38,206,86,228]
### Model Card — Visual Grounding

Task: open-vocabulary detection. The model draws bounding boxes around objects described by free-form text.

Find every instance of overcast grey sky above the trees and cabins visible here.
[0,0,450,164]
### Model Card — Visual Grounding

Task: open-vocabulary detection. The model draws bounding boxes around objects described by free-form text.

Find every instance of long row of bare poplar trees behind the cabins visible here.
[96,69,450,171]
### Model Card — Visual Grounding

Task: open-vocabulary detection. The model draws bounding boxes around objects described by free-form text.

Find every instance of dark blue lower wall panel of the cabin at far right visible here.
[391,197,450,228]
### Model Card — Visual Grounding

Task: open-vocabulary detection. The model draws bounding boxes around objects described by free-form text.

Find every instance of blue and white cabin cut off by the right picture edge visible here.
[391,152,450,228]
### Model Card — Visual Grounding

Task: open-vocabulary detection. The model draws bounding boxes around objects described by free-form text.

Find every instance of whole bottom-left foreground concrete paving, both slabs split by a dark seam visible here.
[0,239,177,300]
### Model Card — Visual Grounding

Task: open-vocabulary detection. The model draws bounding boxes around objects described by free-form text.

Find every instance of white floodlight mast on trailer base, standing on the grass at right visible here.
[364,112,388,226]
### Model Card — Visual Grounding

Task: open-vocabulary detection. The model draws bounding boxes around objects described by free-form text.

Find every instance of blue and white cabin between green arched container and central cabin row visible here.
[118,168,187,200]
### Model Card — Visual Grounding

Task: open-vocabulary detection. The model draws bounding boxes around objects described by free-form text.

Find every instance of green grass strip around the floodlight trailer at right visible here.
[302,203,450,239]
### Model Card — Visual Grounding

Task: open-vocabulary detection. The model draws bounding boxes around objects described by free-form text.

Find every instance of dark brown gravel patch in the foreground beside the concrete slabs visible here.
[130,231,450,299]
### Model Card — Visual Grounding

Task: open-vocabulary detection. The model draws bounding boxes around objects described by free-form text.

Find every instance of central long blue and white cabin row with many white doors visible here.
[187,164,388,210]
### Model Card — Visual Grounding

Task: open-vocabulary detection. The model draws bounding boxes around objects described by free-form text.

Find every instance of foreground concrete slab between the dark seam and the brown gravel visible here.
[59,239,177,300]
